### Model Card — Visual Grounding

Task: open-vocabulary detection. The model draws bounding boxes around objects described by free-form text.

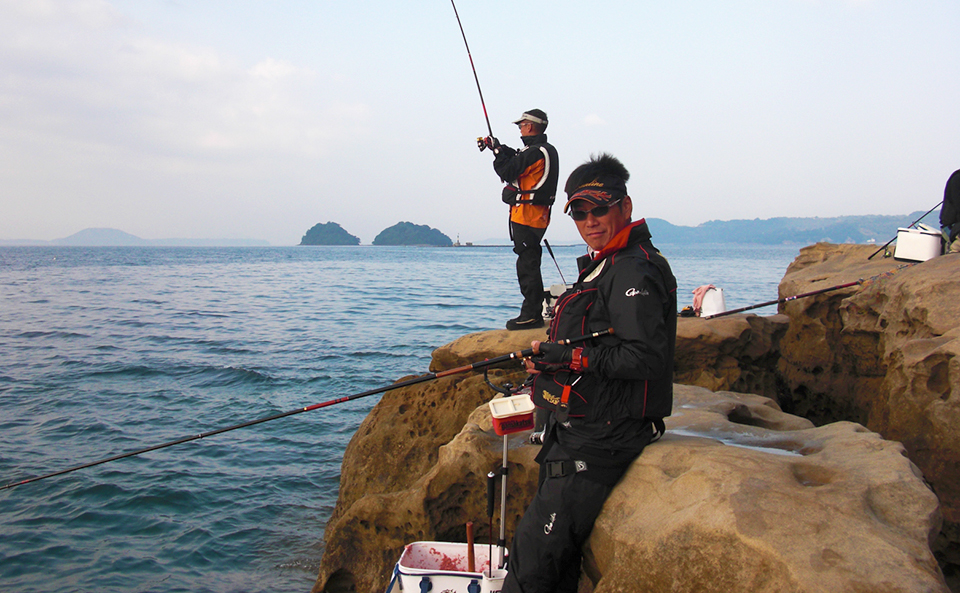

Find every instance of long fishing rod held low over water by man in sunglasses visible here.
[0,328,613,490]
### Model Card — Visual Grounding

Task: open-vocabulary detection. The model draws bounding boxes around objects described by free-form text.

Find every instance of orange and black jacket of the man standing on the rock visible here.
[493,134,560,206]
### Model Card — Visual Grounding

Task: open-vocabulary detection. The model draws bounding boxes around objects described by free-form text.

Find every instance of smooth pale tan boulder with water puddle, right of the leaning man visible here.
[586,388,948,593]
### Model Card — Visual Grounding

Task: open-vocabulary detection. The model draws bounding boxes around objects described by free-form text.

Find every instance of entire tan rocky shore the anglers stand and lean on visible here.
[313,244,960,593]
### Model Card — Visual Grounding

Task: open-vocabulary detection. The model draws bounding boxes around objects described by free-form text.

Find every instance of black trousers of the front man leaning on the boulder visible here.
[503,447,613,593]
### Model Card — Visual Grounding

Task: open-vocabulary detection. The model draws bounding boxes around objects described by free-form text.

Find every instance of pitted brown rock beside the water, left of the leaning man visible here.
[315,329,546,591]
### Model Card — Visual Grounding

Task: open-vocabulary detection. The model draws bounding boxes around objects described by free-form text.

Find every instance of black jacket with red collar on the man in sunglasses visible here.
[533,220,677,463]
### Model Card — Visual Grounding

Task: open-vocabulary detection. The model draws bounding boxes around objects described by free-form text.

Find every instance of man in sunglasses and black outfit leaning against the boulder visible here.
[503,154,677,593]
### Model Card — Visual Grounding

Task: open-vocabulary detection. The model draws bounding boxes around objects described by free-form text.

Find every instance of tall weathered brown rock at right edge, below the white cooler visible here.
[779,244,960,565]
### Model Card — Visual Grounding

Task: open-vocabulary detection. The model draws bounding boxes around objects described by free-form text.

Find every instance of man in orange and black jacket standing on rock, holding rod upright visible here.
[484,109,560,330]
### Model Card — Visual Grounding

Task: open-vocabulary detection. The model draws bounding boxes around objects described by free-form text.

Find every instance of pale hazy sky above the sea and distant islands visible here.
[0,0,960,245]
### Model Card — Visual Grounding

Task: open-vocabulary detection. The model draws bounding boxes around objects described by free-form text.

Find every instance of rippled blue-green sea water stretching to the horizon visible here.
[0,245,798,592]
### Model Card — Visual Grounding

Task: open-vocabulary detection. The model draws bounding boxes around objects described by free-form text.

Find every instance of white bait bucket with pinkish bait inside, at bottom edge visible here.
[387,542,507,593]
